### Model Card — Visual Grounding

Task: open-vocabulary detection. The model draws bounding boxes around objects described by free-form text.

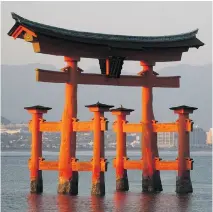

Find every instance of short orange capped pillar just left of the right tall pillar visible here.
[110,105,134,191]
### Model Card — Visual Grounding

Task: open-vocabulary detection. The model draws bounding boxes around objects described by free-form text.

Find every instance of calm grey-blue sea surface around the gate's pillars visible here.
[1,151,212,212]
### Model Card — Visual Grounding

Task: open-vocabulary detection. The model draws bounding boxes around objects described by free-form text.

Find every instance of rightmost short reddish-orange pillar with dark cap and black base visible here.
[170,105,197,194]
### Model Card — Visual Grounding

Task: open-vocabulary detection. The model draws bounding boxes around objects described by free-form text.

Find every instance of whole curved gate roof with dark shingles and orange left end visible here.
[8,13,204,62]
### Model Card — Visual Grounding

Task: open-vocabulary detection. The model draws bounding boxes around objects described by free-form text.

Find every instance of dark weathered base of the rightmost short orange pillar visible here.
[176,171,193,194]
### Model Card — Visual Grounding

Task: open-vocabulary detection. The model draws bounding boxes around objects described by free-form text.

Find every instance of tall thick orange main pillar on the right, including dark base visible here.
[139,62,162,192]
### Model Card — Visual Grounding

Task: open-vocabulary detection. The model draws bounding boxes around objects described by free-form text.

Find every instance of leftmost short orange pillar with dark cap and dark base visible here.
[24,105,51,193]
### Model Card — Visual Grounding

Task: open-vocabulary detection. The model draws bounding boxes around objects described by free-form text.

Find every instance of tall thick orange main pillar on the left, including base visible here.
[58,57,79,195]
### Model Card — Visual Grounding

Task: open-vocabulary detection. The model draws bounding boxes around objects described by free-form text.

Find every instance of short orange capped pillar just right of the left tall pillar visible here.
[86,102,113,196]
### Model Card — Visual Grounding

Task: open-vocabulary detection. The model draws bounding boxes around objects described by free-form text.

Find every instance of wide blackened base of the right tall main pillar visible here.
[142,170,163,193]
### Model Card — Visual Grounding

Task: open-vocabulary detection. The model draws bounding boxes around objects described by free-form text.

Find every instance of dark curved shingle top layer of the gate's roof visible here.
[8,13,204,49]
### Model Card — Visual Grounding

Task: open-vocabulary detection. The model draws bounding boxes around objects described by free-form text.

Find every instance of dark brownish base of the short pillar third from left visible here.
[91,172,105,196]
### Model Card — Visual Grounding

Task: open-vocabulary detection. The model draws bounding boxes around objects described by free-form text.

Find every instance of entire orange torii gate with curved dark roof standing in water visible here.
[8,13,204,195]
